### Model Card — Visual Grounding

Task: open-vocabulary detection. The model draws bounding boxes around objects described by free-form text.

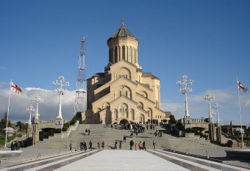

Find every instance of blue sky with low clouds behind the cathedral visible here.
[0,0,250,125]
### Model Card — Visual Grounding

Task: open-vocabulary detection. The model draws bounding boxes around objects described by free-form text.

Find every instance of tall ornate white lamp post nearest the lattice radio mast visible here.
[52,76,69,120]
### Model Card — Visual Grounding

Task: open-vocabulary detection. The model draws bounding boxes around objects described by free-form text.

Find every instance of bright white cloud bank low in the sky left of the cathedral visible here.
[0,87,86,121]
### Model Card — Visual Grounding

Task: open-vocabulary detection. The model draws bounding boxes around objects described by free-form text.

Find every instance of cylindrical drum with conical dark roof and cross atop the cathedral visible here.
[107,19,139,67]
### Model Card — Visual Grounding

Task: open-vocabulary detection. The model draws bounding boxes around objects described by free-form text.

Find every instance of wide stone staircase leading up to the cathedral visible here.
[30,124,229,156]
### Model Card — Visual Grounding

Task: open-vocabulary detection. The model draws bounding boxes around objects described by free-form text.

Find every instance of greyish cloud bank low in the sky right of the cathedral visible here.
[162,89,250,125]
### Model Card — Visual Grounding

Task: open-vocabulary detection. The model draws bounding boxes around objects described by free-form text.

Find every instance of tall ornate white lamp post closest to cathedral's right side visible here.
[176,75,194,118]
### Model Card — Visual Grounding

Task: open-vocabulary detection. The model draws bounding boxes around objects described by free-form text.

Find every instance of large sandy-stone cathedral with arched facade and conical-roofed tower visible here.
[82,22,170,124]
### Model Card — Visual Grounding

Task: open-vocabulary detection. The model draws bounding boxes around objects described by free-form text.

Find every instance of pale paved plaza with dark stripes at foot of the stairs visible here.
[1,150,247,171]
